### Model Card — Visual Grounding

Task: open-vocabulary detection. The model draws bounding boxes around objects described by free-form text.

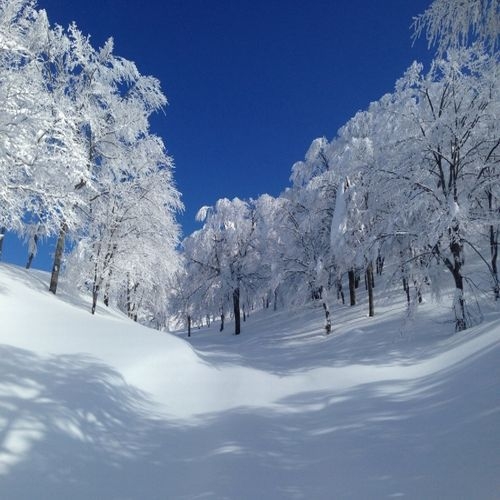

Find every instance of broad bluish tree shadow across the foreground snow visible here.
[0,338,500,500]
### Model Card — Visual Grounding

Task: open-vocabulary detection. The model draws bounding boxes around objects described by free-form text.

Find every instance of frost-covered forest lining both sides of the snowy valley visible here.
[0,0,500,334]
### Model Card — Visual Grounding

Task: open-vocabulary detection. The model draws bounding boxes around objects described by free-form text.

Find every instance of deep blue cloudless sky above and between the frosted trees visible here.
[4,0,431,268]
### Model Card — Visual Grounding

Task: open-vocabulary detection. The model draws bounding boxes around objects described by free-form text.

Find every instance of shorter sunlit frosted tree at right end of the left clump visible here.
[65,136,182,318]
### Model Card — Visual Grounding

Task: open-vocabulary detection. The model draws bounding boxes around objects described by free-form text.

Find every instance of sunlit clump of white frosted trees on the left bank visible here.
[0,0,182,326]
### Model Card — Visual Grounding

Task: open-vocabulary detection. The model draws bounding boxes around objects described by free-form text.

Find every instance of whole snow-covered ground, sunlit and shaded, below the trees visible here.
[0,265,500,500]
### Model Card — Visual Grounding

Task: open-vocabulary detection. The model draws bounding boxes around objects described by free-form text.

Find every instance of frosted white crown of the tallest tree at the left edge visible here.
[0,0,85,254]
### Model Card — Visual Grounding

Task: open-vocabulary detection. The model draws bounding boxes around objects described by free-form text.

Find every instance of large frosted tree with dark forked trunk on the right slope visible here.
[376,46,498,330]
